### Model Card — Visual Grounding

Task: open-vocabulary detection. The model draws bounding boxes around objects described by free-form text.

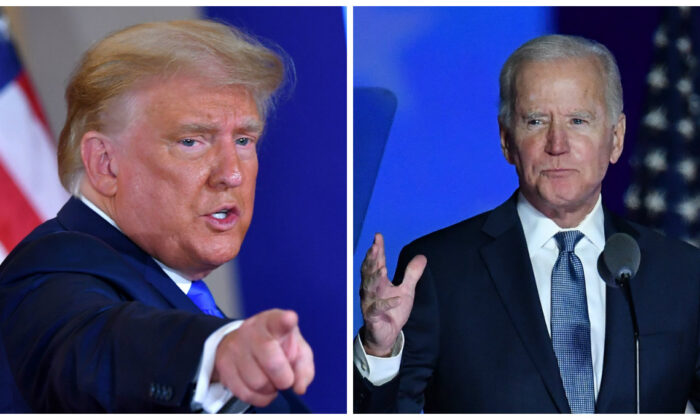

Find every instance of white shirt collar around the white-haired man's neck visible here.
[517,192,605,257]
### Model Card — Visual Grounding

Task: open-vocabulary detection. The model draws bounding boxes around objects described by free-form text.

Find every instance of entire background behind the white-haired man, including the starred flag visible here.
[353,7,700,333]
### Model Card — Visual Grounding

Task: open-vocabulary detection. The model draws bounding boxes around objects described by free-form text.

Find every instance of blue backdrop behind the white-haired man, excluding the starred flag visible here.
[353,7,663,333]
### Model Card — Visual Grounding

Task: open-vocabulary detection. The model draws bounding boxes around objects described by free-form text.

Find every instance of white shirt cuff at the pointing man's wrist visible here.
[190,320,248,413]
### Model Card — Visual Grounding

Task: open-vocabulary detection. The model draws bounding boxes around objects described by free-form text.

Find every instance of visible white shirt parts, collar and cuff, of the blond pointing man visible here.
[80,195,243,413]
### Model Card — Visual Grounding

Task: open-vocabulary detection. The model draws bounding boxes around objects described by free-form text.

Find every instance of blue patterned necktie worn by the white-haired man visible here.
[552,230,595,413]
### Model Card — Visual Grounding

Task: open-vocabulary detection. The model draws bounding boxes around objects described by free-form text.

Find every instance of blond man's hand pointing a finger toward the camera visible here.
[212,309,315,407]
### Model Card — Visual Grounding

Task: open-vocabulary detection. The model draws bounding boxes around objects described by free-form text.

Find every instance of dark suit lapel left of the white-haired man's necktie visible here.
[481,192,570,413]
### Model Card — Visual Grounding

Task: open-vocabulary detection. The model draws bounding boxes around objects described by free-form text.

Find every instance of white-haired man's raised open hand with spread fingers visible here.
[360,233,428,357]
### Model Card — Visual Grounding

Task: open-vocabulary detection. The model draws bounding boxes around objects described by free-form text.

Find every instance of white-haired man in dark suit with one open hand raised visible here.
[354,35,700,413]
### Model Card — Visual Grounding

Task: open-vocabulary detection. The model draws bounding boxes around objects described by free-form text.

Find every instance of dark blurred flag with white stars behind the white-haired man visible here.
[624,7,700,246]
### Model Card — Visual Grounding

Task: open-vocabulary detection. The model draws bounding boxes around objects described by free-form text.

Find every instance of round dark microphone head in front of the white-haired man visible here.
[598,233,642,287]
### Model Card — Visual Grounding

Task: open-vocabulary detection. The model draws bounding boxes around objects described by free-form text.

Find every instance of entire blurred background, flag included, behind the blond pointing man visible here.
[0,7,347,413]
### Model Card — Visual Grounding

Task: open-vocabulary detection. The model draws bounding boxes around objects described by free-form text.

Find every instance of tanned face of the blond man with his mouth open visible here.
[111,76,263,279]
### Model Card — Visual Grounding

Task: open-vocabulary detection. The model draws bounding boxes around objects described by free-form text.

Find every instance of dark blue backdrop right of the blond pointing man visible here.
[205,7,347,413]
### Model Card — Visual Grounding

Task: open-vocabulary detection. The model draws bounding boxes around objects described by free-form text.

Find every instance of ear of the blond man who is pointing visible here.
[80,131,119,197]
